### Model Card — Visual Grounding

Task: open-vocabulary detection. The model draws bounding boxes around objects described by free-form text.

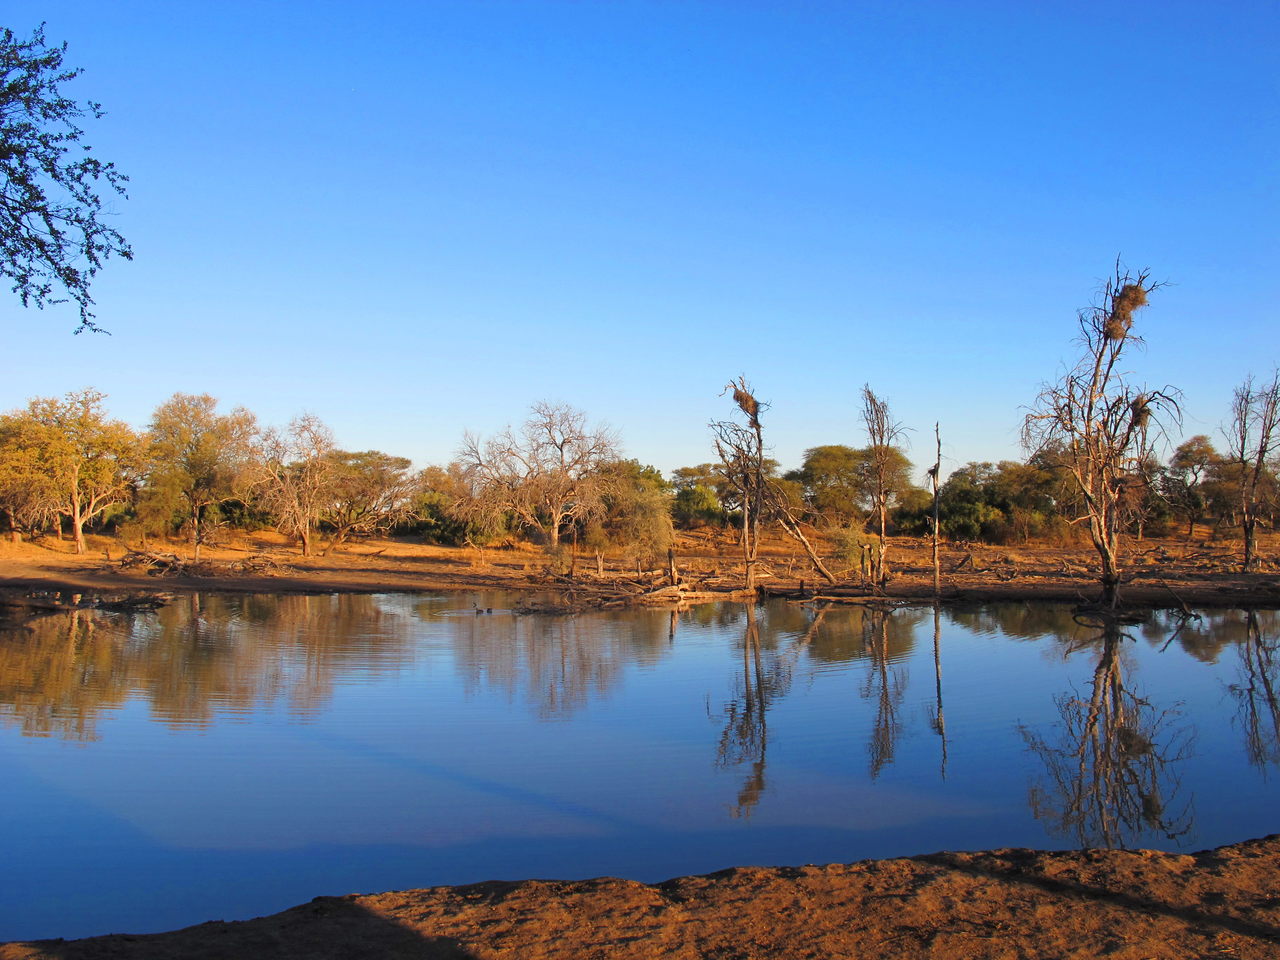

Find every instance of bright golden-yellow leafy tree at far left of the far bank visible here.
[4,389,141,553]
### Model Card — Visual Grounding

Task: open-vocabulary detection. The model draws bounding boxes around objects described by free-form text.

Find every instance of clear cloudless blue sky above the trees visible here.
[0,0,1280,481]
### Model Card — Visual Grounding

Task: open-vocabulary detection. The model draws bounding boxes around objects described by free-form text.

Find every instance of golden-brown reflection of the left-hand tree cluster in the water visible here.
[0,594,412,741]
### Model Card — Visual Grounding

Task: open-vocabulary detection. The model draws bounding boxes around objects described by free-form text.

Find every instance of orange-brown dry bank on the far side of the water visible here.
[0,532,1280,608]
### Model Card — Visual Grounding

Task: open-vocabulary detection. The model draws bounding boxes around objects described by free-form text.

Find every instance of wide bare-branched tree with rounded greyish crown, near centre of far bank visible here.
[458,402,618,549]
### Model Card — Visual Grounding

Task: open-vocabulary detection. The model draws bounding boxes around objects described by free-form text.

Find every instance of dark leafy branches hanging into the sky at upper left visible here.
[0,24,133,332]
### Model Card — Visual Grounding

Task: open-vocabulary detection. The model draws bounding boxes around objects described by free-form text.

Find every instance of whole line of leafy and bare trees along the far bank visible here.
[0,268,1280,590]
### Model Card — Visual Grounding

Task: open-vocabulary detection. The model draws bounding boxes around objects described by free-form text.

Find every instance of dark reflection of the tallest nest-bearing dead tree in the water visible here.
[1020,625,1193,849]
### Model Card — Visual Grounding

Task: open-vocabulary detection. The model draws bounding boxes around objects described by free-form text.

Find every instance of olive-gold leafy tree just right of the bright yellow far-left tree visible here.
[145,393,257,559]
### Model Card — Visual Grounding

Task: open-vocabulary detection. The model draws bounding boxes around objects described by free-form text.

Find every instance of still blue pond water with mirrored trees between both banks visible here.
[0,594,1280,941]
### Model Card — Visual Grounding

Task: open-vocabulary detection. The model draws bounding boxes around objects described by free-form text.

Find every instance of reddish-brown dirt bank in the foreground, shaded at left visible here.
[0,836,1280,960]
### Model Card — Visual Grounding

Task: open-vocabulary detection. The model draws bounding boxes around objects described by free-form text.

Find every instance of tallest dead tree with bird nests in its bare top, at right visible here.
[1023,264,1180,604]
